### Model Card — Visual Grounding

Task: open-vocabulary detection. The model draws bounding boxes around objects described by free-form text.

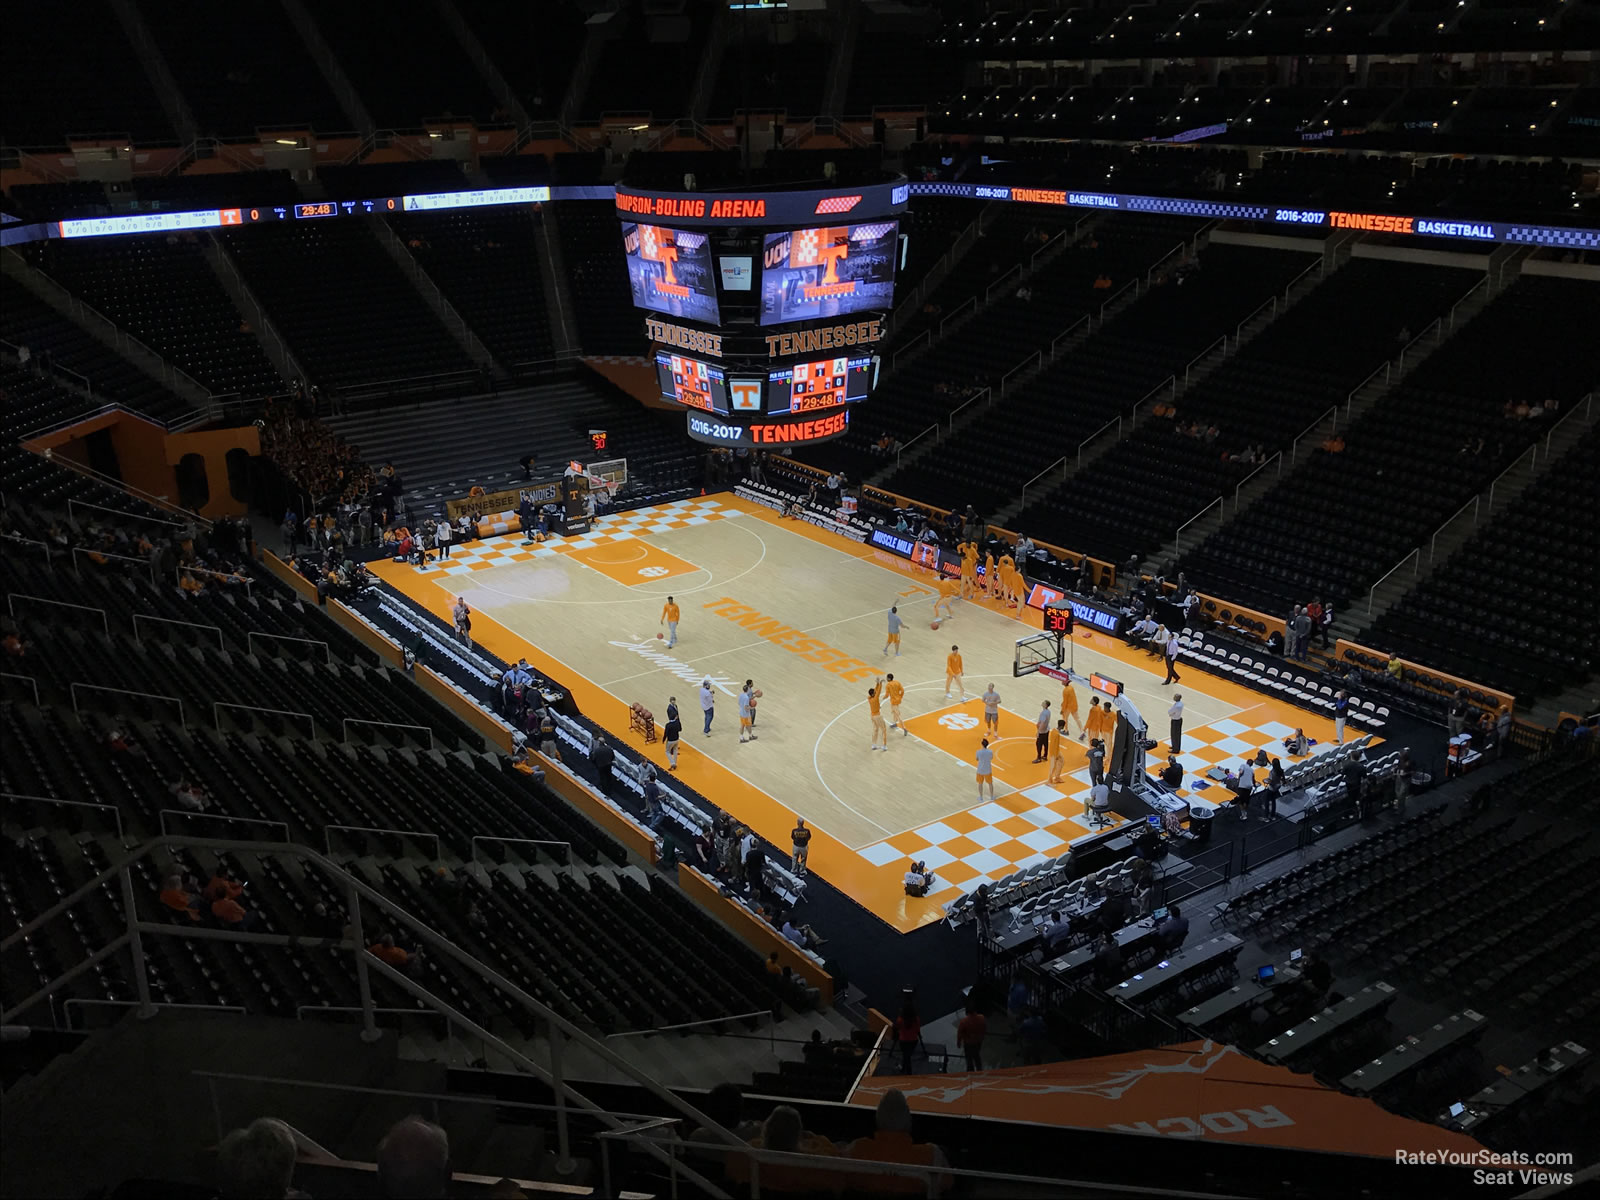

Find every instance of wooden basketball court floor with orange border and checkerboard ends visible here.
[373,493,1363,931]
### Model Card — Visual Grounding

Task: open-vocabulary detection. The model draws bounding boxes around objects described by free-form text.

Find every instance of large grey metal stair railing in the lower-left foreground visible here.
[0,837,742,1195]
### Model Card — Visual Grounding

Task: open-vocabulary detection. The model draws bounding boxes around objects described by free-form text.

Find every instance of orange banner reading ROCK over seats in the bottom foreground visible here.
[851,1042,1483,1160]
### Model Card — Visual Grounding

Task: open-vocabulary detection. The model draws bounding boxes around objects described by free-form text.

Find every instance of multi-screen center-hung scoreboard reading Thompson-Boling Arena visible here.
[616,178,909,446]
